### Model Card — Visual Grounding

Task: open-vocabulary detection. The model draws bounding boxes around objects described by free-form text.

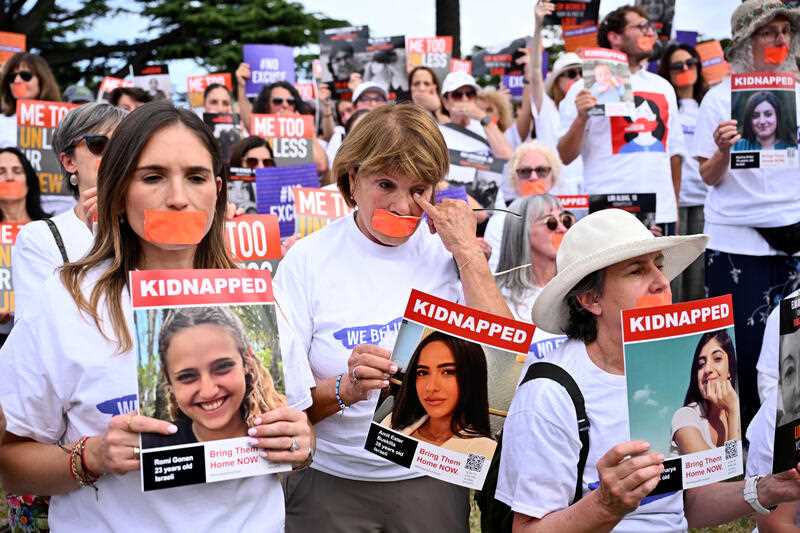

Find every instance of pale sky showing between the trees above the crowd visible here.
[83,0,740,91]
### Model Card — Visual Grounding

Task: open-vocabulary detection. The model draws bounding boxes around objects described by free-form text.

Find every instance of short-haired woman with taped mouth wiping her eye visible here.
[275,104,510,533]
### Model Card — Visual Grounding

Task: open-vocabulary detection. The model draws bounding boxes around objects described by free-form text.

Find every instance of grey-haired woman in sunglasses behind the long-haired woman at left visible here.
[11,102,127,317]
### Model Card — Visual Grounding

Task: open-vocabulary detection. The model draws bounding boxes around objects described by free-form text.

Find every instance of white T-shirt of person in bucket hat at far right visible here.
[693,78,800,256]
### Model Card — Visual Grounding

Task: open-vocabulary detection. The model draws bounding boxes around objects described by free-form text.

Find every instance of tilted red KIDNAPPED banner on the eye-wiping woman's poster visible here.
[403,289,536,353]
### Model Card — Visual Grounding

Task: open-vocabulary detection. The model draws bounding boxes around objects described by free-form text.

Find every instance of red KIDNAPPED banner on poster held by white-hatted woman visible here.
[622,294,733,342]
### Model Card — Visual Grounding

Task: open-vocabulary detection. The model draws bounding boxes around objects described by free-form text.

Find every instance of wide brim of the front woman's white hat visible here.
[531,234,708,334]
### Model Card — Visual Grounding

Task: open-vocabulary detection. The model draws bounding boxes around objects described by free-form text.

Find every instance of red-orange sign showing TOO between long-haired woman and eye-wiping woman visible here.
[225,215,281,261]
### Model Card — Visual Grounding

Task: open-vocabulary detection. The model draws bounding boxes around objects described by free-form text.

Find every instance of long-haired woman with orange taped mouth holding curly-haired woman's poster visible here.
[0,101,313,532]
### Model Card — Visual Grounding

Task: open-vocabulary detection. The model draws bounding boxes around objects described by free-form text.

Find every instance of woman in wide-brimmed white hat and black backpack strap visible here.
[495,209,800,533]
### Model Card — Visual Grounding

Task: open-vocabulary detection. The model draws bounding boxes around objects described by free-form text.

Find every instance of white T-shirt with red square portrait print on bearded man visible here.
[559,69,685,223]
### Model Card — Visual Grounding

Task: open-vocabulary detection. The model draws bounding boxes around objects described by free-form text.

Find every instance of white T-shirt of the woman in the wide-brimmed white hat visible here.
[495,340,687,533]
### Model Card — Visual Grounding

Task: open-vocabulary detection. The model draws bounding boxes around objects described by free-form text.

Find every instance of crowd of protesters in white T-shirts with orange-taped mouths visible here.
[0,0,800,533]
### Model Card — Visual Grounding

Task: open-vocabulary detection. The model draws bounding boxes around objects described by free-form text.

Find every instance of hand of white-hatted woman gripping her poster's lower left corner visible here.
[597,441,664,518]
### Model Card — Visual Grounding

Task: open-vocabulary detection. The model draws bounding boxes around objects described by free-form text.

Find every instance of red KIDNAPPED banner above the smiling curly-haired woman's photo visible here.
[131,269,274,309]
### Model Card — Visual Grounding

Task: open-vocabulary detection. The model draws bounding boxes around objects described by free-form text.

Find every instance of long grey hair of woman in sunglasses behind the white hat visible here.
[495,194,562,303]
